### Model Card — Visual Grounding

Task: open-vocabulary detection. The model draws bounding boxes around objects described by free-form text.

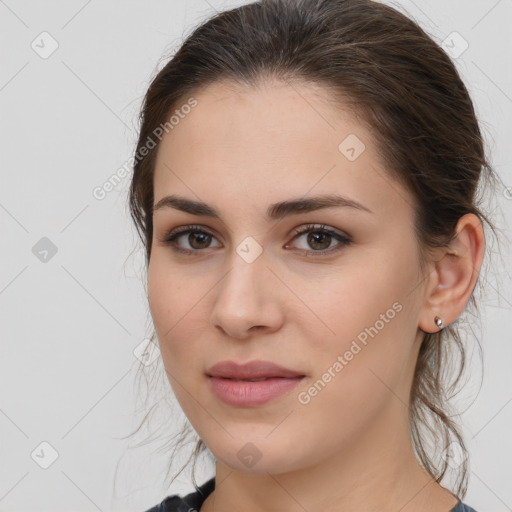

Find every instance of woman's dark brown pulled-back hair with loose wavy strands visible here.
[129,0,495,498]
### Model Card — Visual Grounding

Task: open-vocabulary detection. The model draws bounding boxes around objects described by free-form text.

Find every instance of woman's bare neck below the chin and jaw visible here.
[201,399,458,512]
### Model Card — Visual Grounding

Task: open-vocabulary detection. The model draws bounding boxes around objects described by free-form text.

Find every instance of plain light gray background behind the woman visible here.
[0,0,512,512]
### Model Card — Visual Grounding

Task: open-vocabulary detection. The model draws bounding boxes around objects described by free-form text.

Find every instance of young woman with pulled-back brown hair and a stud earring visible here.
[130,0,493,512]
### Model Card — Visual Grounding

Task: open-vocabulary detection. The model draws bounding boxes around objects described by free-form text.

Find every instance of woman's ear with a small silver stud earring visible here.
[418,213,485,333]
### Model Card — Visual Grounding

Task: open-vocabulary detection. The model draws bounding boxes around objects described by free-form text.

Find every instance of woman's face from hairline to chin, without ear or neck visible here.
[148,78,425,473]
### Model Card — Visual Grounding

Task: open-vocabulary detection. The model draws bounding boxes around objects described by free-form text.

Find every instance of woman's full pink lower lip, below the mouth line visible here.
[209,377,304,407]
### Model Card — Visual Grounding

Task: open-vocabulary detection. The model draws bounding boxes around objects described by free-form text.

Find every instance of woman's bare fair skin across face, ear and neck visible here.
[148,81,484,512]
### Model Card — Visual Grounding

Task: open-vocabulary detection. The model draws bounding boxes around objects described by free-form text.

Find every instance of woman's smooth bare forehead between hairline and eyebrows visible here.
[154,81,412,219]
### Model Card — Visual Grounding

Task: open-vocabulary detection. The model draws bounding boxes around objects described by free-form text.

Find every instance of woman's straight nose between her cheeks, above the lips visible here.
[211,248,286,339]
